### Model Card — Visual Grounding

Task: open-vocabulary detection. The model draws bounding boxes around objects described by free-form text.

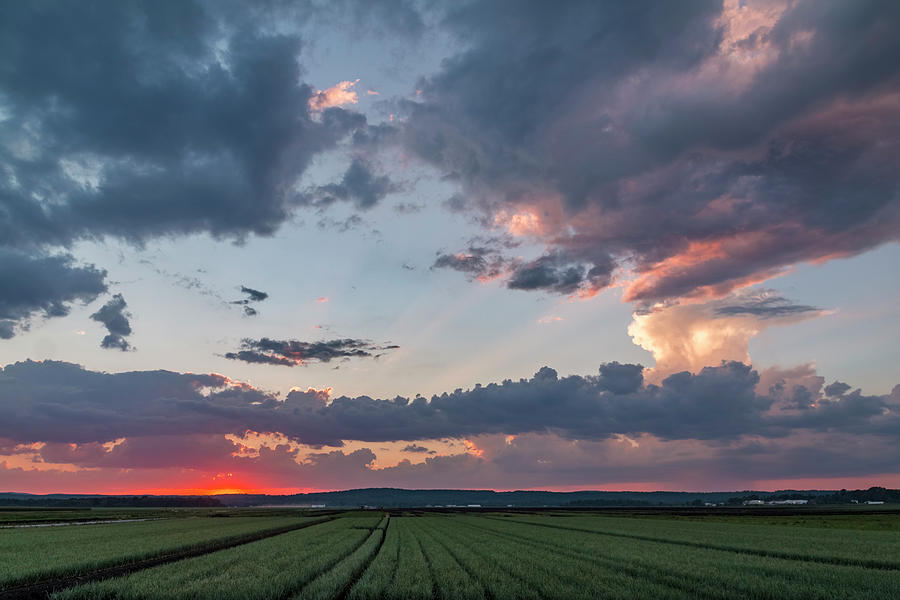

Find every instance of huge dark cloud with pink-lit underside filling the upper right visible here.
[390,0,900,305]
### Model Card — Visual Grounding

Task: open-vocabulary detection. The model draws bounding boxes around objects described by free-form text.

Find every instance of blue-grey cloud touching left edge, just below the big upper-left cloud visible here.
[0,246,106,339]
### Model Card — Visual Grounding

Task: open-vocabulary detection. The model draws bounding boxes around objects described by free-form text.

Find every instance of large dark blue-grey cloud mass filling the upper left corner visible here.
[0,1,372,337]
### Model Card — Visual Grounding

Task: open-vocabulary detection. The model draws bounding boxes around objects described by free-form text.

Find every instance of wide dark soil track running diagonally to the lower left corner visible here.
[0,513,337,600]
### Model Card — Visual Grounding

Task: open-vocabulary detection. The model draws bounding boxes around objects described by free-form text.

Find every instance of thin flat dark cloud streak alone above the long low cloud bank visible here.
[225,338,399,367]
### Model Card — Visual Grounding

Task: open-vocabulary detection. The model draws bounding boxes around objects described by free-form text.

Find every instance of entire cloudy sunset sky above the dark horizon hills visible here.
[0,0,900,494]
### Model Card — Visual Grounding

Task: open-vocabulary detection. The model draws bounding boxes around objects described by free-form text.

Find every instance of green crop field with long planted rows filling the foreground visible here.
[0,511,900,600]
